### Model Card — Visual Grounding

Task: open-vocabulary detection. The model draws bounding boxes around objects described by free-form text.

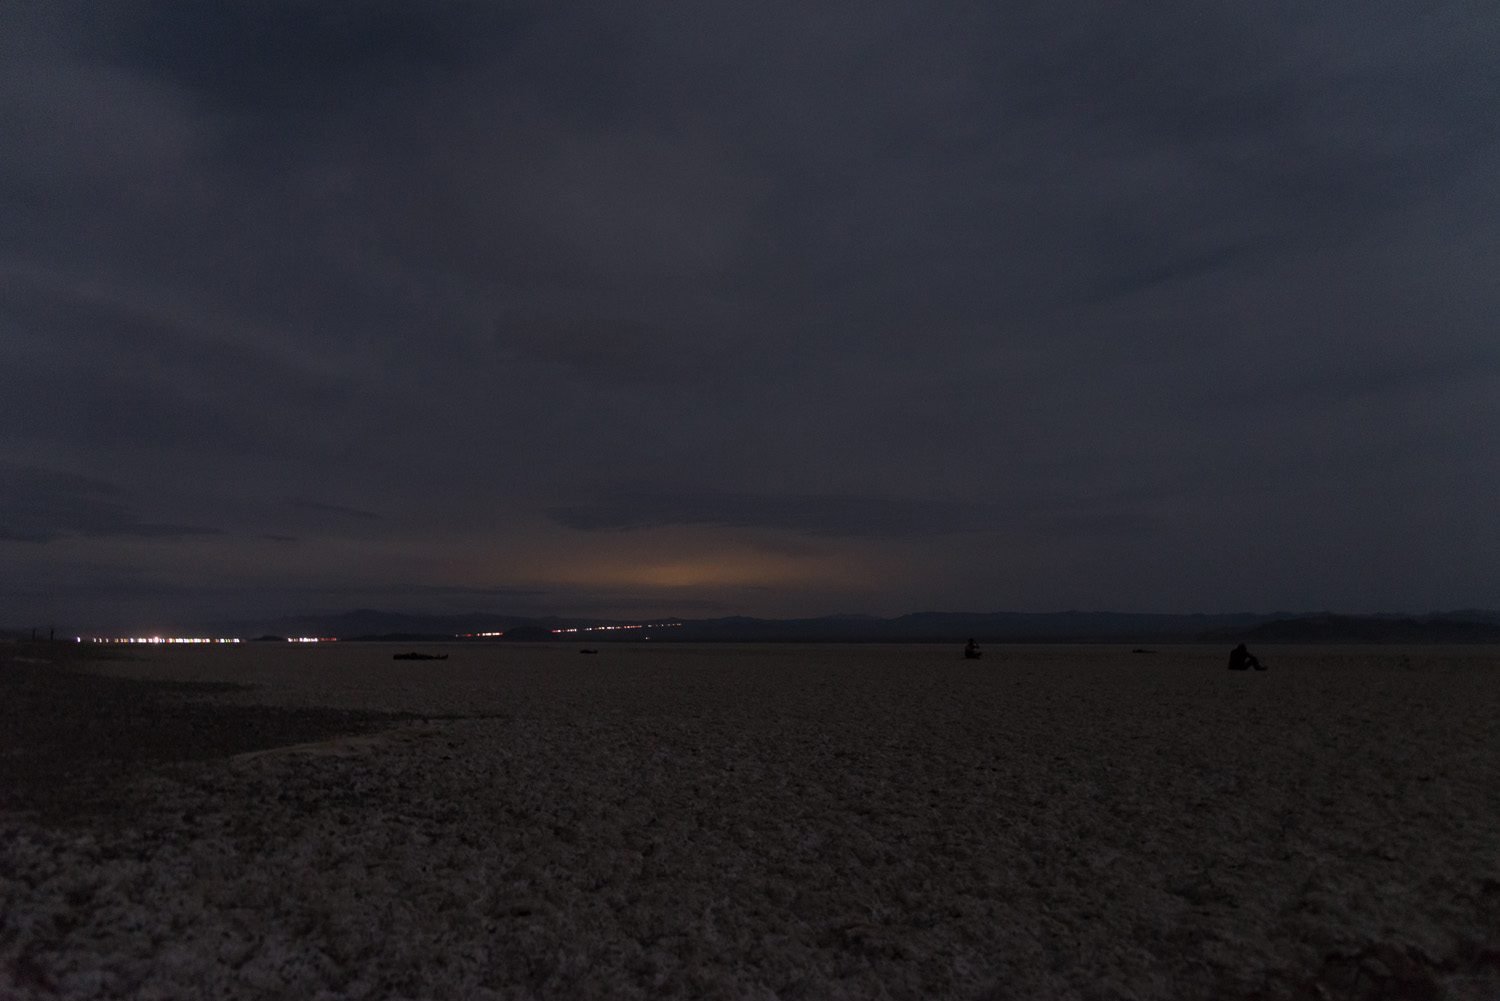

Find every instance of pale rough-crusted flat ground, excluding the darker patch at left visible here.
[0,644,1500,999]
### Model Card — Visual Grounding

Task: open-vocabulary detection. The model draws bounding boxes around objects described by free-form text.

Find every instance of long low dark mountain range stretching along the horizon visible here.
[193,609,1500,644]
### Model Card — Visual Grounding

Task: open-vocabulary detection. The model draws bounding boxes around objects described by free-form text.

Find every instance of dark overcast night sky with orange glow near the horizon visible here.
[0,0,1500,626]
